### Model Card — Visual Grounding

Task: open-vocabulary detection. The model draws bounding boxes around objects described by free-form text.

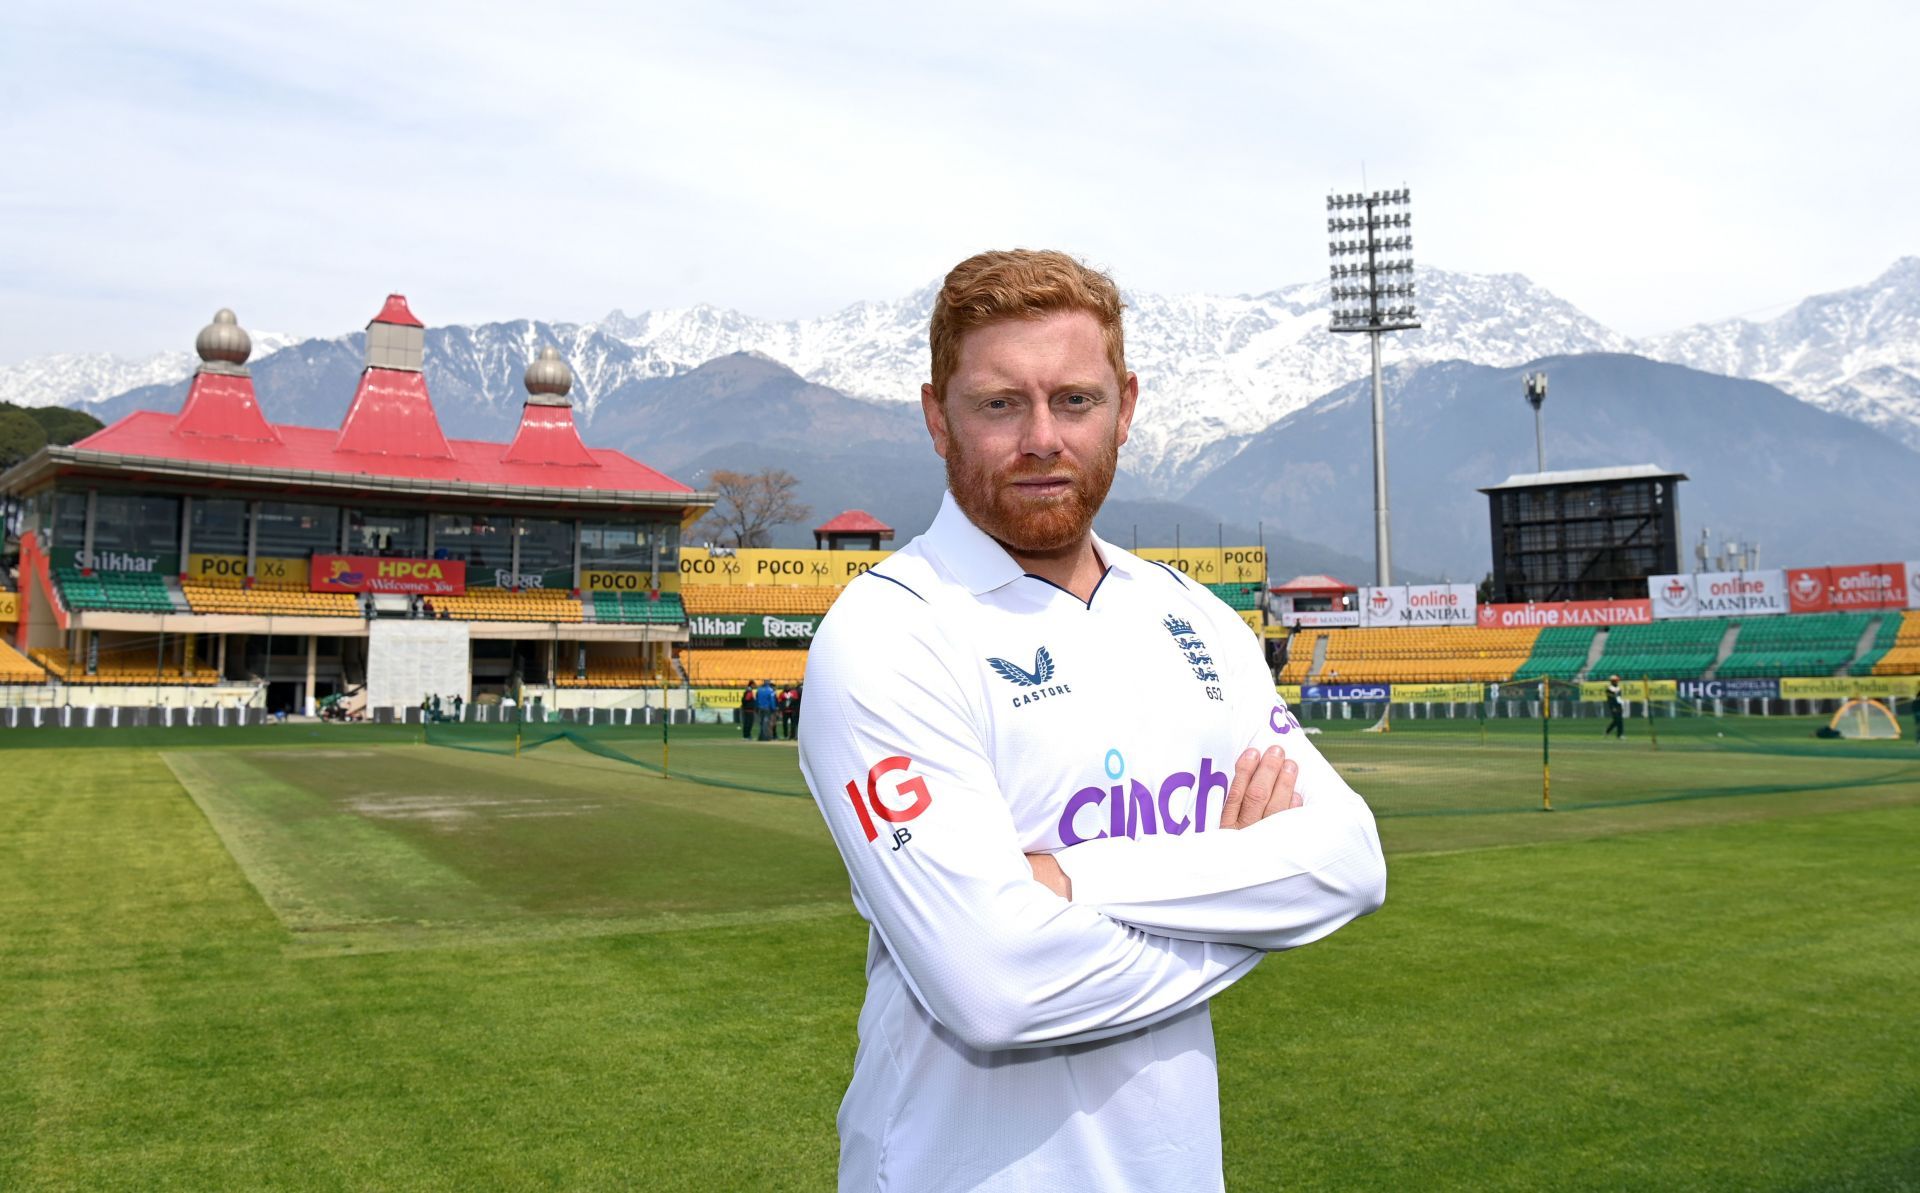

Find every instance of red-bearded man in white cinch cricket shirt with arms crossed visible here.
[801,252,1386,1193]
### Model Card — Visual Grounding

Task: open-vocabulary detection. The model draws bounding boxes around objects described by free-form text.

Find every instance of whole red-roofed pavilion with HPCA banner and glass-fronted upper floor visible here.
[0,294,714,711]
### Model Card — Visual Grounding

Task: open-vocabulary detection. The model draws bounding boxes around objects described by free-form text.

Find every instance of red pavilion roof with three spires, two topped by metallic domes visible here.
[0,294,714,513]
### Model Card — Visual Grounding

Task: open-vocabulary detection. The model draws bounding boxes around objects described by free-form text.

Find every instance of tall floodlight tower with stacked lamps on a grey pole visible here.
[1327,186,1419,588]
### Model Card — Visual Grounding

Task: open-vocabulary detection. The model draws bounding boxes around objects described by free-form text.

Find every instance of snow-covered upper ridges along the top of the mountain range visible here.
[15,257,1920,494]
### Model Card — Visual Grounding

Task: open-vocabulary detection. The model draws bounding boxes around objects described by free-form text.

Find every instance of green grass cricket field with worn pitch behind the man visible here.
[0,722,1920,1189]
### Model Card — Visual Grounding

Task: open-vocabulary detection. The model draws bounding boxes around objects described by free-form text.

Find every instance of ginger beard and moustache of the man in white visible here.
[947,418,1119,555]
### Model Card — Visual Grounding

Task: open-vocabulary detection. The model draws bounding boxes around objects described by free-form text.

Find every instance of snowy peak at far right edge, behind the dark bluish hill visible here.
[1638,257,1920,450]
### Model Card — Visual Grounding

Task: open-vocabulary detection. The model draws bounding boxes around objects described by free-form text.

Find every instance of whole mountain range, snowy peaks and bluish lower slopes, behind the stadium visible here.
[0,257,1920,576]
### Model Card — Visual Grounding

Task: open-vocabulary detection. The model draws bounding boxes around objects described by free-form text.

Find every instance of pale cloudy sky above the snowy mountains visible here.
[0,0,1920,363]
